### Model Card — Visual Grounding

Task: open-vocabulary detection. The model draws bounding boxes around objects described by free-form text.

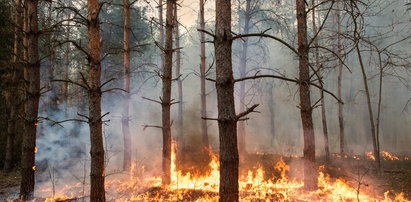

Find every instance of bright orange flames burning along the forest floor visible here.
[38,144,410,201]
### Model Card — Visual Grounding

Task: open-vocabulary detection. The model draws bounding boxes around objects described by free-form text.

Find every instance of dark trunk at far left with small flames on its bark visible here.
[20,0,40,200]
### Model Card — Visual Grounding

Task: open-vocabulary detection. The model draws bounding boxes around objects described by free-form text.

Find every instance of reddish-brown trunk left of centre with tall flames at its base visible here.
[161,0,176,184]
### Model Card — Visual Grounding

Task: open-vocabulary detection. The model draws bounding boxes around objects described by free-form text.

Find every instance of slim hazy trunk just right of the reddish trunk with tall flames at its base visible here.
[174,4,184,145]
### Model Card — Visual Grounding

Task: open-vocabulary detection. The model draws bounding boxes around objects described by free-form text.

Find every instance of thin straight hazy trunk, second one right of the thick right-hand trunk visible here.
[336,0,345,154]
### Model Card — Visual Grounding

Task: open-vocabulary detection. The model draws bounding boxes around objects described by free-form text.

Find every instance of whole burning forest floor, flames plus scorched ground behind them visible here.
[0,144,411,201]
